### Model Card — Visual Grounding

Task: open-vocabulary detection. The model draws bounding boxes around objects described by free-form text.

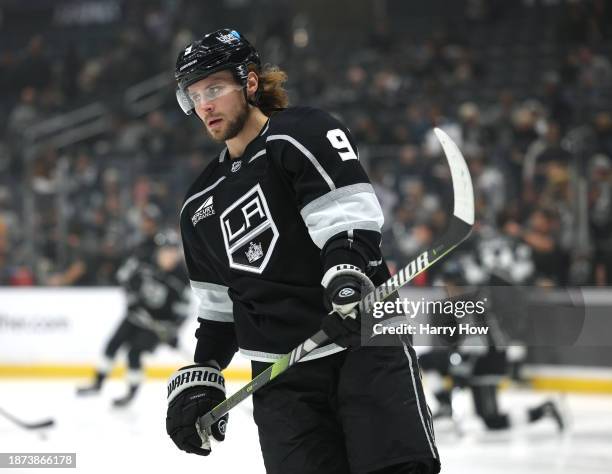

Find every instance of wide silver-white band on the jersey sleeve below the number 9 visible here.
[300,183,384,248]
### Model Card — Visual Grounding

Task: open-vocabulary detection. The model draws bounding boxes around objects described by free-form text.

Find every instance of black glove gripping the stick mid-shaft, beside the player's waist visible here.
[321,265,374,347]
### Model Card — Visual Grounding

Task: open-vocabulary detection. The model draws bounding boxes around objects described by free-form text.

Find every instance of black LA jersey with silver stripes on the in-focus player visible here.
[180,107,388,366]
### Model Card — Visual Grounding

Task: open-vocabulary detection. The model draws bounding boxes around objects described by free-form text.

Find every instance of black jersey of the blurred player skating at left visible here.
[117,252,191,339]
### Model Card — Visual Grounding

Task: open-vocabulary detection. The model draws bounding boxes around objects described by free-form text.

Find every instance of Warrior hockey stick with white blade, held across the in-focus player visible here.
[198,128,474,429]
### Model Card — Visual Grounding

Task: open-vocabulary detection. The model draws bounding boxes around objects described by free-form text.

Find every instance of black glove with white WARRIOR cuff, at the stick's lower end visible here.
[166,363,229,456]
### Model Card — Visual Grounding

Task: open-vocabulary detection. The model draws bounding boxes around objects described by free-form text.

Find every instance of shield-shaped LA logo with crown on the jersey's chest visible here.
[220,184,278,274]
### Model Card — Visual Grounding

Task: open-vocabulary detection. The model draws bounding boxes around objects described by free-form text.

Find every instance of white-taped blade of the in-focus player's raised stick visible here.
[434,128,474,226]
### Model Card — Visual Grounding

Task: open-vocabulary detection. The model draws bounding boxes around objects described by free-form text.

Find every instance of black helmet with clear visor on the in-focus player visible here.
[174,28,261,115]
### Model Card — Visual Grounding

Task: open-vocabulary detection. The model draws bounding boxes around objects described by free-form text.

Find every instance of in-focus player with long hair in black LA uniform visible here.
[166,29,440,474]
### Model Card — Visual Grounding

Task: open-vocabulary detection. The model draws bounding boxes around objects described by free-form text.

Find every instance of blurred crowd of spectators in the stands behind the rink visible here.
[0,0,612,285]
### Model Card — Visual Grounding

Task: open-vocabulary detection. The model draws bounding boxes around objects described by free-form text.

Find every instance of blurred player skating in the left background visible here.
[77,231,190,407]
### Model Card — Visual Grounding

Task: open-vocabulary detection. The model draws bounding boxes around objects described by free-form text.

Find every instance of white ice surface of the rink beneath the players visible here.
[0,380,612,474]
